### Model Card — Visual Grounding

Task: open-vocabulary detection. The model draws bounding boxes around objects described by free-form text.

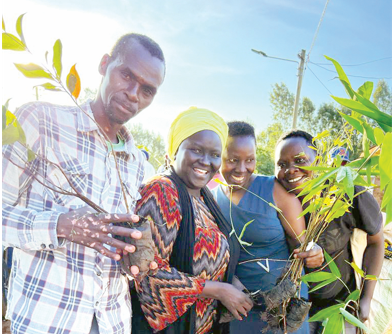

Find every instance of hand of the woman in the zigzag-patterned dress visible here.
[201,281,253,320]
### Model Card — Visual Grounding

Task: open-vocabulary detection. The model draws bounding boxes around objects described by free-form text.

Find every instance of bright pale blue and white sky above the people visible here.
[2,0,392,136]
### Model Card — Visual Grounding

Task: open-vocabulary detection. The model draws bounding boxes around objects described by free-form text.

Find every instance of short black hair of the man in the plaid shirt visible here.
[111,33,166,67]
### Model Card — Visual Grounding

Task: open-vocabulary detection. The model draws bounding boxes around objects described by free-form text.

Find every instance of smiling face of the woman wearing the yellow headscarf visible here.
[174,130,222,196]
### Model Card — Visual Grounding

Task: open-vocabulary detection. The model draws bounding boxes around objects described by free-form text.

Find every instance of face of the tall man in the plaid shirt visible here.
[99,41,165,124]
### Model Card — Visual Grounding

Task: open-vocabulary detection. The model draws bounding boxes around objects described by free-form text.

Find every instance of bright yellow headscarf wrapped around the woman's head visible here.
[168,107,229,161]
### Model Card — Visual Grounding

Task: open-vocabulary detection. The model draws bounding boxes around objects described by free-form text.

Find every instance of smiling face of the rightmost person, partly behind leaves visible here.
[275,137,316,195]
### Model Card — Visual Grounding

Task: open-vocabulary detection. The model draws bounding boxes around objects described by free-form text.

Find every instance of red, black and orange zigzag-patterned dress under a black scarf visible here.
[136,176,230,333]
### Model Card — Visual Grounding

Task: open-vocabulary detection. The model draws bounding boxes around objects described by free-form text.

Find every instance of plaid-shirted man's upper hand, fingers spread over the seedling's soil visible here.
[57,207,142,260]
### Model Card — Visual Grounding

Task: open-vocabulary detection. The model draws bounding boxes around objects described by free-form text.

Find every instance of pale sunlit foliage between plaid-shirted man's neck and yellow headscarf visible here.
[127,123,165,170]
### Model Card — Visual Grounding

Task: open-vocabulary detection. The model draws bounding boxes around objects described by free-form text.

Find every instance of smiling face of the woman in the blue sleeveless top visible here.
[221,136,256,192]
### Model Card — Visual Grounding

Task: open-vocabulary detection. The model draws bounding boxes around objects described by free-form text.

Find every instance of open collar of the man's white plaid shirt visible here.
[76,100,138,159]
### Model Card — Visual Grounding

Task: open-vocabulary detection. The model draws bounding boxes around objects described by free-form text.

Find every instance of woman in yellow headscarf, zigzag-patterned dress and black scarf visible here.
[132,108,252,334]
